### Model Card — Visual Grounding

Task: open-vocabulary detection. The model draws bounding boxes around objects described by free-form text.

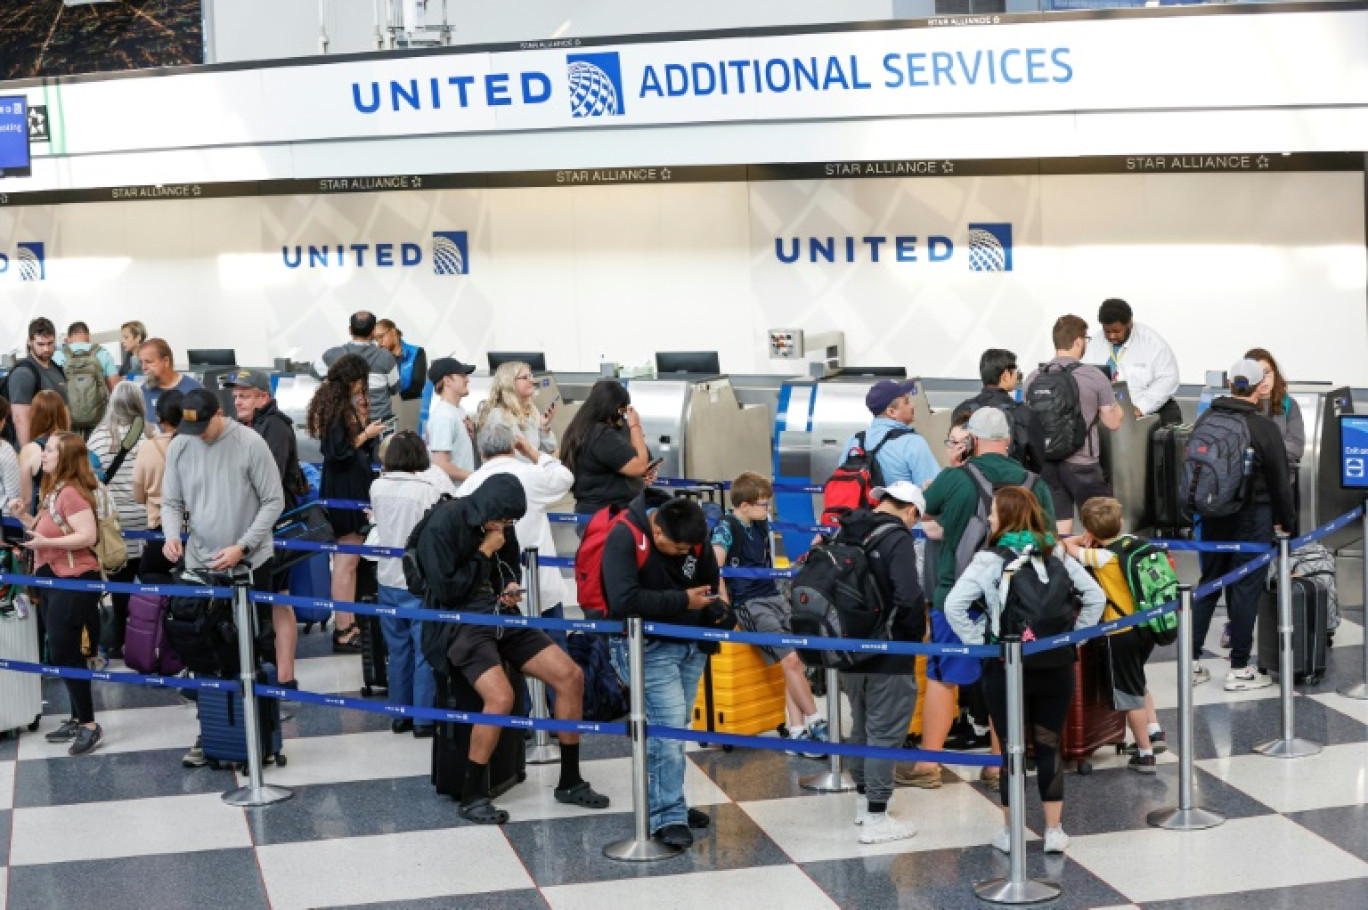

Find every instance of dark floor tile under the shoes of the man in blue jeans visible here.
[503,803,788,887]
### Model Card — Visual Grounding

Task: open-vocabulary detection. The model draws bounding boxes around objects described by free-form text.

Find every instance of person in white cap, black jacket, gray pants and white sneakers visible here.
[837,480,926,844]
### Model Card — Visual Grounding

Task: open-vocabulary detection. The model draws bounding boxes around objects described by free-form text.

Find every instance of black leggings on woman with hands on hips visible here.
[984,661,1074,806]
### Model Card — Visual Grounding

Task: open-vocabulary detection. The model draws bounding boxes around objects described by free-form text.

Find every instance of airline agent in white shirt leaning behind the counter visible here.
[1083,297,1183,426]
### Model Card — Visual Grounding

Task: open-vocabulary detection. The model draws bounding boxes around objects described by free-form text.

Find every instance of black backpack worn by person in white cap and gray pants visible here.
[789,521,899,671]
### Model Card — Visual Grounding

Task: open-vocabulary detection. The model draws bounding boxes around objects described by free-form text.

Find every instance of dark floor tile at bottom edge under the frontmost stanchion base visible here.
[802,847,1129,910]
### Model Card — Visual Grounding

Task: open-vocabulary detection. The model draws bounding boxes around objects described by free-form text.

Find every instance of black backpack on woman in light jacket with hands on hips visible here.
[989,547,1077,669]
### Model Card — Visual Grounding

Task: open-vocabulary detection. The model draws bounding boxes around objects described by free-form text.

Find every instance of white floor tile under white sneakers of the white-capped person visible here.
[740,784,1003,862]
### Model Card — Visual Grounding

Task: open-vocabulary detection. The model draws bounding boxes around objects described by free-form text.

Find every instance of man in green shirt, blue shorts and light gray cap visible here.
[897,408,1055,790]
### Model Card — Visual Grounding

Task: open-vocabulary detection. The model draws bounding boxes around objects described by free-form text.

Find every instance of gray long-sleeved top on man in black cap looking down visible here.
[161,420,285,569]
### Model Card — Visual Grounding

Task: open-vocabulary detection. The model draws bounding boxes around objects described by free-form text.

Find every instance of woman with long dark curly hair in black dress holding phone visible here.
[308,354,384,653]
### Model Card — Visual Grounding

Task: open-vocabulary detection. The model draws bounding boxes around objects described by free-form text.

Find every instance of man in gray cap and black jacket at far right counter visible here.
[1193,359,1297,691]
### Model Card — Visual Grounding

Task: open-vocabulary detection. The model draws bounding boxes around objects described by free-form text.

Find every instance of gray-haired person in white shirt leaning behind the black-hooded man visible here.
[456,423,575,618]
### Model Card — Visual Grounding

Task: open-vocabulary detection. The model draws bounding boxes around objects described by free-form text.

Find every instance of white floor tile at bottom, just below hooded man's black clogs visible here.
[257,828,534,910]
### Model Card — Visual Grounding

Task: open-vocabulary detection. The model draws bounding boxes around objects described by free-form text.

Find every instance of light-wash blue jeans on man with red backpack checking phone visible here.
[610,638,707,835]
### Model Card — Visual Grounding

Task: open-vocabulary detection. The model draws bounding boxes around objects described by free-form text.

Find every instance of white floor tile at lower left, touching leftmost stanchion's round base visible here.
[10,794,252,866]
